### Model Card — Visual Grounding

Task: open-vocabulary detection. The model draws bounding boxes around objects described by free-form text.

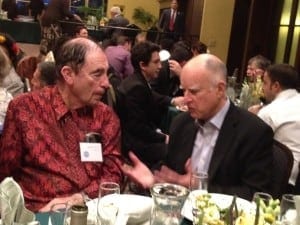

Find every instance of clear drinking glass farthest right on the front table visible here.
[280,194,297,225]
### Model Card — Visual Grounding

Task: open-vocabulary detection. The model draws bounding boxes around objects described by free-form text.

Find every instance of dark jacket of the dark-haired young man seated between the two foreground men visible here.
[117,73,171,155]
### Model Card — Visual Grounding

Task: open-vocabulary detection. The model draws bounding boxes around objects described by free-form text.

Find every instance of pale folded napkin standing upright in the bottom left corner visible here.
[0,177,35,225]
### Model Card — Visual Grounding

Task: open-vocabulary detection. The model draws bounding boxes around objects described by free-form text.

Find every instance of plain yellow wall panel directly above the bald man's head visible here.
[200,0,235,62]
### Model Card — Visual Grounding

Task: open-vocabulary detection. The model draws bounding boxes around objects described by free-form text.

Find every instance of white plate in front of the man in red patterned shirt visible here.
[87,194,153,225]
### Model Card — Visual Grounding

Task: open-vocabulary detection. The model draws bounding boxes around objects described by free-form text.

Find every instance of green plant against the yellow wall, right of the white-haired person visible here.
[132,7,157,29]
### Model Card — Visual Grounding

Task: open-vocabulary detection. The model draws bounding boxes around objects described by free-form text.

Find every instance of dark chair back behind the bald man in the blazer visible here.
[271,140,294,199]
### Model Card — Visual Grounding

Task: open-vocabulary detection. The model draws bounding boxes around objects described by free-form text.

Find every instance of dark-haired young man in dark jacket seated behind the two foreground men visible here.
[117,42,180,167]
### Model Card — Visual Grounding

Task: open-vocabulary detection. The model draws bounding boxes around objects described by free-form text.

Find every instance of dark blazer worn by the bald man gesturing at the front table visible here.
[166,103,273,200]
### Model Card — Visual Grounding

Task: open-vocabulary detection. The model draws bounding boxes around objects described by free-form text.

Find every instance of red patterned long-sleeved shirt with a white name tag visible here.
[0,87,123,211]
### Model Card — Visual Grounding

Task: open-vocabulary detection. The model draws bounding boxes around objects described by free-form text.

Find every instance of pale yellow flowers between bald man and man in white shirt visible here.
[238,76,263,109]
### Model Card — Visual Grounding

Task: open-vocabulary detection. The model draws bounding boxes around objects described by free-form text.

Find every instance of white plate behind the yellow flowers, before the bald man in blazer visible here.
[181,190,255,221]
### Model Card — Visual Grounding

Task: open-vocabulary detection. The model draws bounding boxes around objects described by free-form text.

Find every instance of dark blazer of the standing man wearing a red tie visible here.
[159,9,185,39]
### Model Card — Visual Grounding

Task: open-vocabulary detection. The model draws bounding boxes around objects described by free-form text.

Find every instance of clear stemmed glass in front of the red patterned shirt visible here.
[97,182,120,225]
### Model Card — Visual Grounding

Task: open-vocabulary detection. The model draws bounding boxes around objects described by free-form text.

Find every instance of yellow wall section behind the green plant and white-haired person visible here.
[106,0,160,25]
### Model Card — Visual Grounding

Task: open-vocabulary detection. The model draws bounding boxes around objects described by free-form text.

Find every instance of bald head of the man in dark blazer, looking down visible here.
[180,54,227,120]
